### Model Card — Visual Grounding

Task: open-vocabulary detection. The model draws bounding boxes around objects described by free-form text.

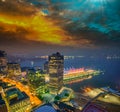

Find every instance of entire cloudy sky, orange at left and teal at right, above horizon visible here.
[0,0,120,55]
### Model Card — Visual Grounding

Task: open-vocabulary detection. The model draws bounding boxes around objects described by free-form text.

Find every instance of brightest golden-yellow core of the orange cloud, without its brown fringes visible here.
[0,13,72,44]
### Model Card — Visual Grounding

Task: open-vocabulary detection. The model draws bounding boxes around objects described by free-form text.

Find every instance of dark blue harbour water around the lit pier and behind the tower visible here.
[21,57,120,92]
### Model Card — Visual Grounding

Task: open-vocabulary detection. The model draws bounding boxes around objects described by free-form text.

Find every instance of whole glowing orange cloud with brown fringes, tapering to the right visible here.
[0,2,92,46]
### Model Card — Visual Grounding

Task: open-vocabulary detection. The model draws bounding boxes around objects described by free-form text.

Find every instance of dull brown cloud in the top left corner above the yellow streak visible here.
[0,0,36,16]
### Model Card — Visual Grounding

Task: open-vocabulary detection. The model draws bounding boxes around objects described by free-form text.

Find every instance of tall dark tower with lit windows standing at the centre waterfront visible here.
[48,52,64,94]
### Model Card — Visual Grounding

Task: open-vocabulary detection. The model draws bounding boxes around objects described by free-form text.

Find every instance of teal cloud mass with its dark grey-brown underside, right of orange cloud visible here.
[26,0,120,45]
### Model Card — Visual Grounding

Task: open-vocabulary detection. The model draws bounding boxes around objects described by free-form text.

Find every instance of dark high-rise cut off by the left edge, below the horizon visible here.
[0,50,7,75]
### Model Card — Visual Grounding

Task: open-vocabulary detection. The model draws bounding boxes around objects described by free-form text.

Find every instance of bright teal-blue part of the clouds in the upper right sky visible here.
[26,0,120,39]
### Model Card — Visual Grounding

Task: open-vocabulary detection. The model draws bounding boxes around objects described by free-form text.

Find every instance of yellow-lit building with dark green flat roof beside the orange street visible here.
[5,88,31,112]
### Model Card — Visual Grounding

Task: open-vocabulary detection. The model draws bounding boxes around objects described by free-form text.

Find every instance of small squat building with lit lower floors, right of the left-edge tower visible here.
[8,63,21,76]
